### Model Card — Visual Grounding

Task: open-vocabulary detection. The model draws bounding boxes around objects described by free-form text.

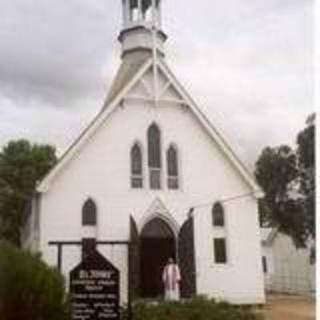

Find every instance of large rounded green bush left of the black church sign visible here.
[0,242,66,320]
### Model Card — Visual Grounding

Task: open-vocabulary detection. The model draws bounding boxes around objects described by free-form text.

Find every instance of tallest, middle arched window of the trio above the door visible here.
[148,124,161,189]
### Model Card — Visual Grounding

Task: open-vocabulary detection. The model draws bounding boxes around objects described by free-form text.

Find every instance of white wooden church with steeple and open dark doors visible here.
[24,0,265,304]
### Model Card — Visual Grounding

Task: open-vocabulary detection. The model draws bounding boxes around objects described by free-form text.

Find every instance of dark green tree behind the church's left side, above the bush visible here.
[0,140,57,245]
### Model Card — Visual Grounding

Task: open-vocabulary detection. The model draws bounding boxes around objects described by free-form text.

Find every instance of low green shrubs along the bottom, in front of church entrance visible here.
[122,297,262,320]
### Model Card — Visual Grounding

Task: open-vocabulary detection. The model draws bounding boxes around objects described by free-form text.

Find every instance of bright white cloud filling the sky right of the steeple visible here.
[165,0,313,167]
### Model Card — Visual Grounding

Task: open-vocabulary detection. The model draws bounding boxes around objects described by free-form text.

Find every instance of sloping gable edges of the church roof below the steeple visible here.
[37,58,262,197]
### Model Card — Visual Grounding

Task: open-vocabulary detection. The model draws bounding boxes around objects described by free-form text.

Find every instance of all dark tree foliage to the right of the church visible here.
[255,114,315,247]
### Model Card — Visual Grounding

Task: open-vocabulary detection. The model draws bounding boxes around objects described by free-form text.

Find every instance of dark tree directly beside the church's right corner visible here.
[255,146,307,247]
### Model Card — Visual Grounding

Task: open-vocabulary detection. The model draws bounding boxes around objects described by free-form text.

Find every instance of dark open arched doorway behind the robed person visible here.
[140,218,176,298]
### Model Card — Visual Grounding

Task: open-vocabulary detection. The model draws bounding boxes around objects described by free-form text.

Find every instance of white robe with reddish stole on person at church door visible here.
[162,264,181,301]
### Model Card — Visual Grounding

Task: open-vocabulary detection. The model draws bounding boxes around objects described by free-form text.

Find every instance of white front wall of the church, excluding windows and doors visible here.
[40,70,264,303]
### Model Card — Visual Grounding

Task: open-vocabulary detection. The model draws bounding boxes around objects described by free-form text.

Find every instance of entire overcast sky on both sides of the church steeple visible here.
[0,0,313,166]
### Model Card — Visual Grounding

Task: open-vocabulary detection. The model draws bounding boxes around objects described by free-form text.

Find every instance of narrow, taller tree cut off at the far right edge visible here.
[297,115,316,239]
